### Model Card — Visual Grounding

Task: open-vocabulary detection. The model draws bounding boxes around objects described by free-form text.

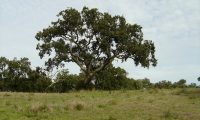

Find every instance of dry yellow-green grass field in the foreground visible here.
[0,88,200,120]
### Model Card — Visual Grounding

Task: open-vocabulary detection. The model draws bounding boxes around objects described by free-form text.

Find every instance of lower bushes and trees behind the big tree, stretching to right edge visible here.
[49,65,199,92]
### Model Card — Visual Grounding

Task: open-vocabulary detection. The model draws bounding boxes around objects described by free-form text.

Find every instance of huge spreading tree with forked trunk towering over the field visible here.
[35,7,157,85]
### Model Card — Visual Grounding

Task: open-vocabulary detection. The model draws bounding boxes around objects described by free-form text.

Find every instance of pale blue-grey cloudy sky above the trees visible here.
[0,0,200,84]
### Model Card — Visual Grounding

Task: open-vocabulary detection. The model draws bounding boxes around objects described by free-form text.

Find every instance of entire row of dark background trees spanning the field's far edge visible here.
[0,57,199,92]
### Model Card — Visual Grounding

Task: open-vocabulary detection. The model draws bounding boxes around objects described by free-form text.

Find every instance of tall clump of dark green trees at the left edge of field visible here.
[0,57,51,92]
